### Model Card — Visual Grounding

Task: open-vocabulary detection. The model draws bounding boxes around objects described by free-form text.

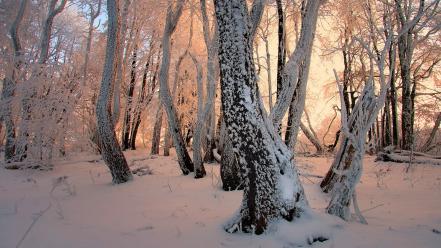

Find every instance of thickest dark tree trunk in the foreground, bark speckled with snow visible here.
[215,0,306,234]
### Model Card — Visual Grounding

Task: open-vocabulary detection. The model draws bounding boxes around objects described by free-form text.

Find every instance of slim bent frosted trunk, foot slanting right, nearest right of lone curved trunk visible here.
[159,1,194,175]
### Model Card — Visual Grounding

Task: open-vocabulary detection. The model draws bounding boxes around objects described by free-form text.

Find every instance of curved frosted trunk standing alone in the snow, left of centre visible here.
[96,0,132,184]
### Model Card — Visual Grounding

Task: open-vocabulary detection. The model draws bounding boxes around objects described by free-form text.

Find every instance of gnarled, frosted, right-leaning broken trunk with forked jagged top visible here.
[322,18,395,217]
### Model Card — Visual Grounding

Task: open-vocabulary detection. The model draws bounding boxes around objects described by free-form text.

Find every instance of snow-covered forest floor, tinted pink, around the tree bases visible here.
[0,151,441,248]
